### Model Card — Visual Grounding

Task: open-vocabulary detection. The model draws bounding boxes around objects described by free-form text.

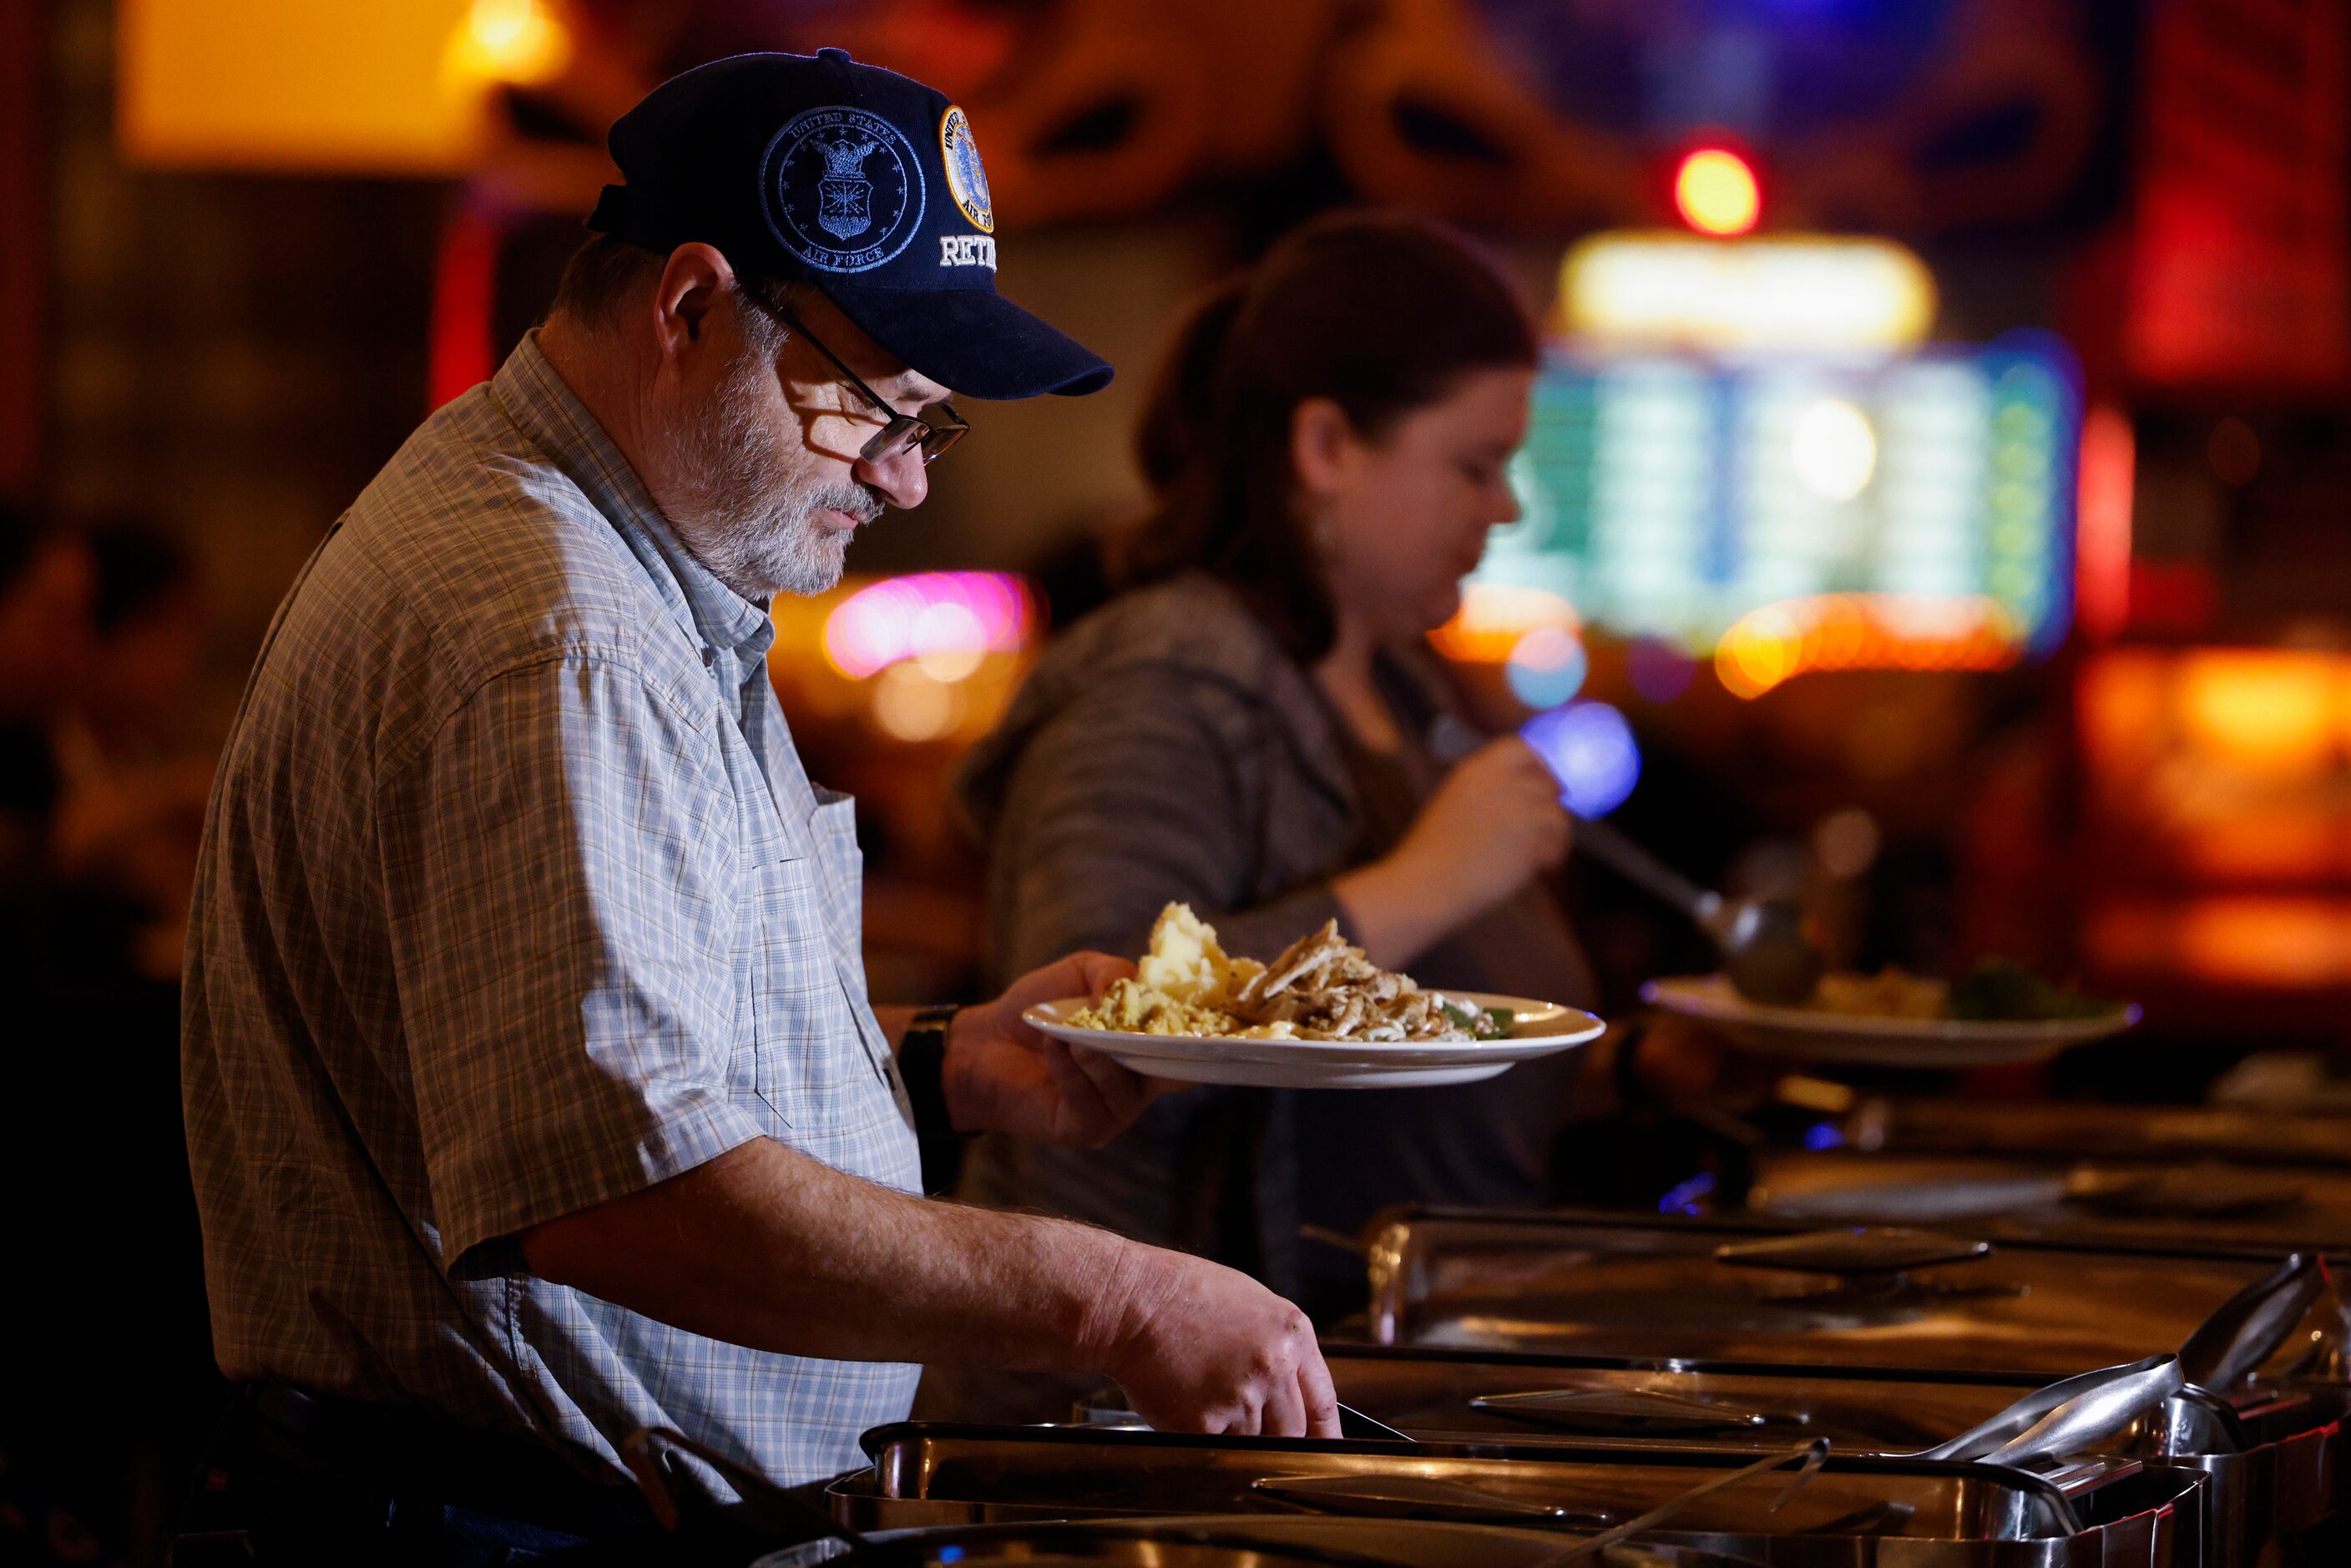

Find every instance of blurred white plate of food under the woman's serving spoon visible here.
[1641,975,2140,1067]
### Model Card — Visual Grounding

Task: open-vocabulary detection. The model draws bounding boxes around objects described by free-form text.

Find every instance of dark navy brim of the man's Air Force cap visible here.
[818,282,1112,400]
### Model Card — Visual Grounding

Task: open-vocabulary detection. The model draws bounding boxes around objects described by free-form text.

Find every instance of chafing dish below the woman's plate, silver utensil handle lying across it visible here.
[1747,1150,2351,1256]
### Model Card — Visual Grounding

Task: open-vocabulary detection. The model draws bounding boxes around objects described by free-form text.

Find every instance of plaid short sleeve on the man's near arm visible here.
[378,656,761,1277]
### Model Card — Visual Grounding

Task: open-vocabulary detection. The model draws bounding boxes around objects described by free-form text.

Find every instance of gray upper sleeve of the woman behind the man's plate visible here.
[990,665,1340,978]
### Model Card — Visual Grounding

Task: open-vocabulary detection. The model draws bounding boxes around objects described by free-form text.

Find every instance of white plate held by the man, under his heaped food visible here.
[1020,992,1608,1089]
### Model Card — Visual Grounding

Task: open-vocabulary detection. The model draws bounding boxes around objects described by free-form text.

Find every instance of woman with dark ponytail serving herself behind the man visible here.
[940,211,1711,1382]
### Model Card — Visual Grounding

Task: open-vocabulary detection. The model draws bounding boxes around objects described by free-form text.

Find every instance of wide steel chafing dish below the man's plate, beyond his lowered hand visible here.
[1366,1208,2342,1378]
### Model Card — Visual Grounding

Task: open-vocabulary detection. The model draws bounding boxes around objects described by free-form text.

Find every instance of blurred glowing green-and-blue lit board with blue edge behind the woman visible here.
[1467,341,2078,691]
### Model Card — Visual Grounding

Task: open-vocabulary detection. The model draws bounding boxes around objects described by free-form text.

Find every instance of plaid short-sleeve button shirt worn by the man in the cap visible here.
[181,331,919,1490]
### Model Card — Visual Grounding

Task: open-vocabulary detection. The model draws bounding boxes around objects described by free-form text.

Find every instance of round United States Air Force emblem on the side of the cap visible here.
[764,109,924,273]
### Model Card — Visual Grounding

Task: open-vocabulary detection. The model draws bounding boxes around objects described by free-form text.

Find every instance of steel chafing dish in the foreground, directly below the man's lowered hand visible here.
[830,1422,2198,1568]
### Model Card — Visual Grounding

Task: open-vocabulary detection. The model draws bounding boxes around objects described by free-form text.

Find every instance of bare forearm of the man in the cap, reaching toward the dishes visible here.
[522,1138,1164,1370]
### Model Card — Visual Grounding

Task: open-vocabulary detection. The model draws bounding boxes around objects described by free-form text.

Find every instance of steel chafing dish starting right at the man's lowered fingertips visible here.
[1326,1345,2344,1568]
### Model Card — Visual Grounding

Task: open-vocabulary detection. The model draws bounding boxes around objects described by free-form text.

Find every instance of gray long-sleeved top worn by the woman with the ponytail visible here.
[962,574,1591,1325]
